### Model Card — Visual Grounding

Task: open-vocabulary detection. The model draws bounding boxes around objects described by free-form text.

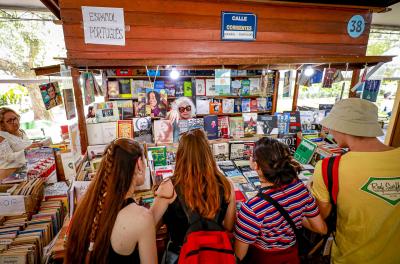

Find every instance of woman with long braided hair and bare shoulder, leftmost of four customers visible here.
[65,138,157,264]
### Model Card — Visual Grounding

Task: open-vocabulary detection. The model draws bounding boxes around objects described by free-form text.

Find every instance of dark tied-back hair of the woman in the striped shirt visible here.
[253,137,301,188]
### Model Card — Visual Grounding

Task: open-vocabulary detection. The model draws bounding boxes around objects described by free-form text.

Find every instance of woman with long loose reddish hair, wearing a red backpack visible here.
[150,129,236,263]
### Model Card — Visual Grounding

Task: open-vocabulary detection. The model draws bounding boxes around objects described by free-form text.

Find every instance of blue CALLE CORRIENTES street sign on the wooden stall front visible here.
[221,12,257,41]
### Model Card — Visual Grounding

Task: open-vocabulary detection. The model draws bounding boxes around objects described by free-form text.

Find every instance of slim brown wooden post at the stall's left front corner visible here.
[71,68,88,155]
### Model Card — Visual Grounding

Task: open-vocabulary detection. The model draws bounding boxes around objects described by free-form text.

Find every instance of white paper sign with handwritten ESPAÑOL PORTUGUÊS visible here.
[82,6,125,46]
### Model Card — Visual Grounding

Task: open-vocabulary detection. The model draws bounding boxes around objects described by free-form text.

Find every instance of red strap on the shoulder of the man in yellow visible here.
[322,156,341,205]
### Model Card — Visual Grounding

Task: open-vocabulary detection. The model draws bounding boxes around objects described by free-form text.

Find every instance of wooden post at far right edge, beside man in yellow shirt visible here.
[385,81,400,148]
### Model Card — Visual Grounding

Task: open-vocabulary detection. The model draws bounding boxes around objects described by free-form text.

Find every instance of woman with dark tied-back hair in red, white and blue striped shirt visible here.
[234,137,327,264]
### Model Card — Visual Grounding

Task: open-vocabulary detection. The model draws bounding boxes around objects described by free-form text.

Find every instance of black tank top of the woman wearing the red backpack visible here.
[163,188,228,253]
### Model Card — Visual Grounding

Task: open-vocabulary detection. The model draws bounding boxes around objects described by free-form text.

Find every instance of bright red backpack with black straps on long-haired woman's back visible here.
[178,195,236,264]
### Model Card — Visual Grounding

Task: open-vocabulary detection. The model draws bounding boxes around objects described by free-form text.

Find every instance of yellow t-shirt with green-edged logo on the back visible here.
[311,148,400,264]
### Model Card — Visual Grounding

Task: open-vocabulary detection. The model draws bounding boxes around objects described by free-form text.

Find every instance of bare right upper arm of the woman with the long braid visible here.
[138,210,158,264]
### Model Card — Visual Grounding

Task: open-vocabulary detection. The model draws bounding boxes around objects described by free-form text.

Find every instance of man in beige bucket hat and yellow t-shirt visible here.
[311,98,400,264]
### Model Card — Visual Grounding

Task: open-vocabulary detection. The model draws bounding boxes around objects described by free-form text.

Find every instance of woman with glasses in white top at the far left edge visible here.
[0,107,42,180]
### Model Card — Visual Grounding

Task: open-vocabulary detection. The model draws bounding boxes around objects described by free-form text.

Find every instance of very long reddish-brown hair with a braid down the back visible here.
[64,138,143,263]
